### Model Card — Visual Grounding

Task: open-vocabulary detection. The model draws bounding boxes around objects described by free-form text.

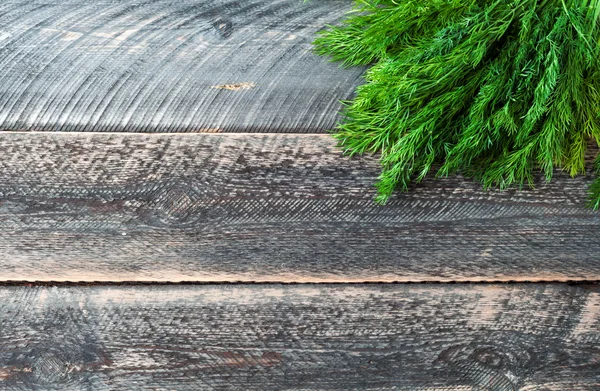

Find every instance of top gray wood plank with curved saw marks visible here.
[0,0,363,133]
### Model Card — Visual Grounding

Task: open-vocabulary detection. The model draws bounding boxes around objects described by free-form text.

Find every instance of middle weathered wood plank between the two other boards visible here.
[0,132,600,282]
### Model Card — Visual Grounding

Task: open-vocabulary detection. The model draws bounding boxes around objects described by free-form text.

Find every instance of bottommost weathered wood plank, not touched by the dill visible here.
[0,284,600,391]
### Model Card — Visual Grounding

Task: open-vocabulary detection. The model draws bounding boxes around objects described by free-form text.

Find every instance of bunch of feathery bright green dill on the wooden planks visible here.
[315,0,600,209]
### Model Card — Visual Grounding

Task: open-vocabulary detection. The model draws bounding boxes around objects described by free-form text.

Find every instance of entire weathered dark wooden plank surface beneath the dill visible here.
[0,0,600,391]
